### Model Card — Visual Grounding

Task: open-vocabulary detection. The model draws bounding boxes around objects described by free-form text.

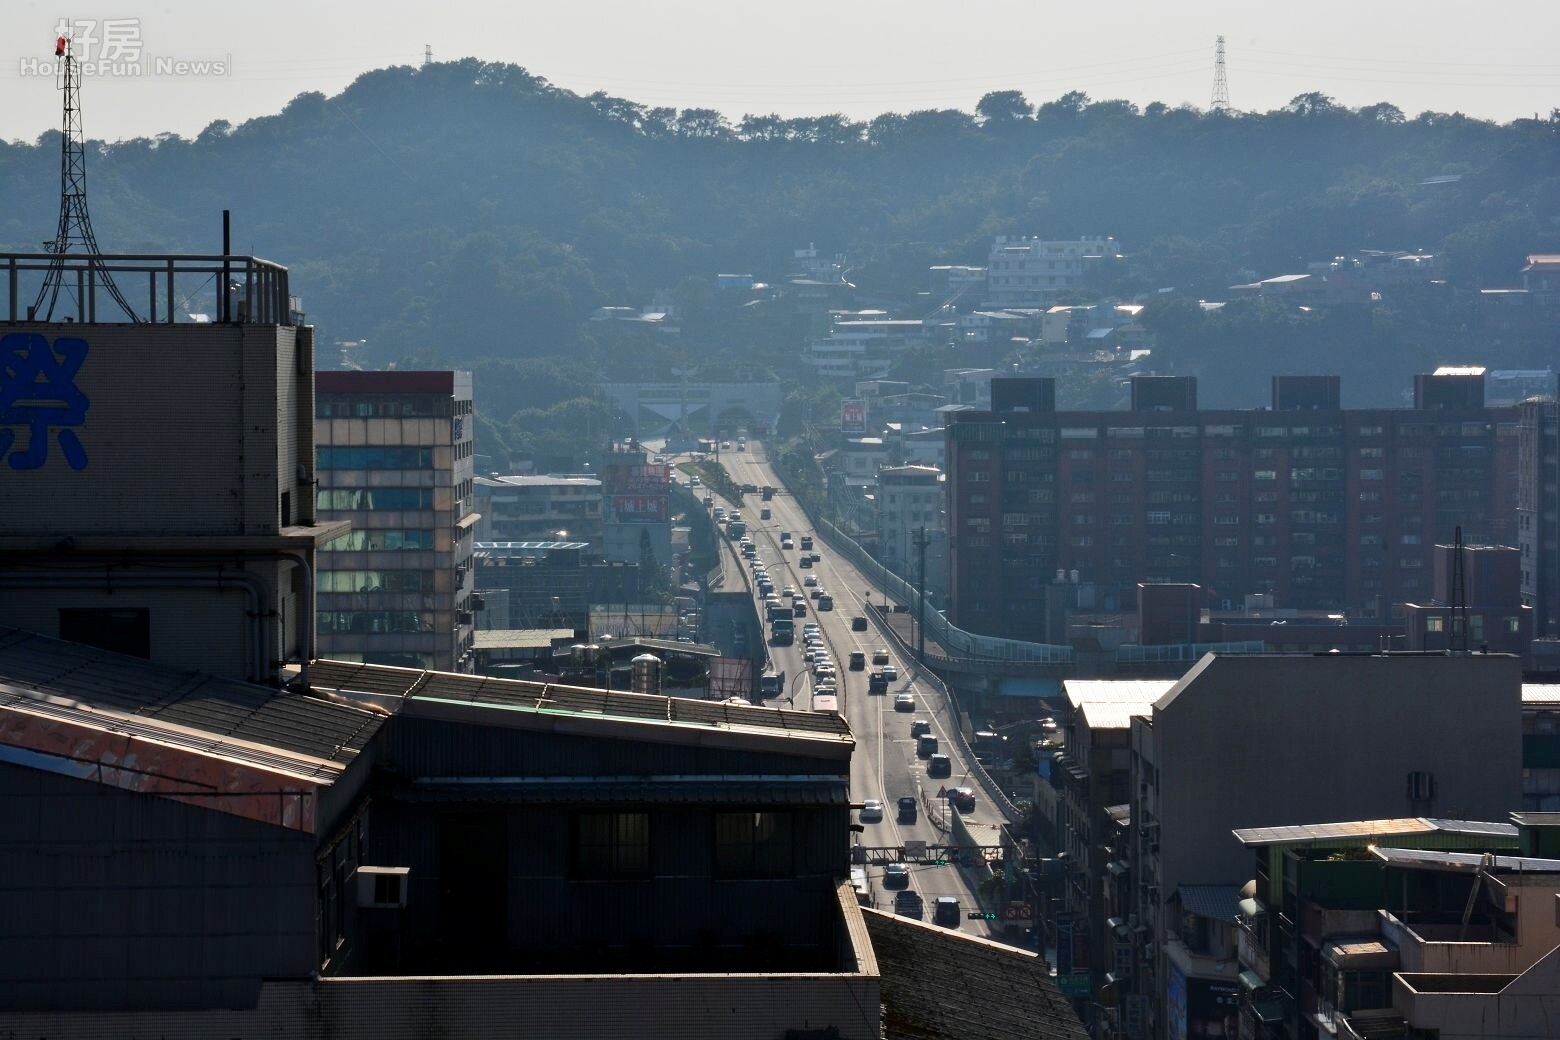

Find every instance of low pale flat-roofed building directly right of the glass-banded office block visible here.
[473,474,602,545]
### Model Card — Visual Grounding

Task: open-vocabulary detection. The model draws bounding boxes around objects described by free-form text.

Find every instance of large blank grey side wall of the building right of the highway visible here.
[1153,655,1523,897]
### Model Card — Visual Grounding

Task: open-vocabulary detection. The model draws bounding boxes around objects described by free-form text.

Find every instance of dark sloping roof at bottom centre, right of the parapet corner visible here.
[861,909,1089,1040]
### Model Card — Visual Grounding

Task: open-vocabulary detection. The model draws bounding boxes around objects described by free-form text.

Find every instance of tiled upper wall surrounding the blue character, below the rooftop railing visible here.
[0,324,301,536]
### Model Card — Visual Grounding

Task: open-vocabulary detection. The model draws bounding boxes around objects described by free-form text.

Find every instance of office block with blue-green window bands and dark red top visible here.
[315,371,477,672]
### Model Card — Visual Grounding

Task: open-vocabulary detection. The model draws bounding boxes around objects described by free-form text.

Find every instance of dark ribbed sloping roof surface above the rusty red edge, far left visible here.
[0,628,384,767]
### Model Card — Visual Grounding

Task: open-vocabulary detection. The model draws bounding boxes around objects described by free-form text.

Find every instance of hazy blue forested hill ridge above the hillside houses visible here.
[0,59,1560,382]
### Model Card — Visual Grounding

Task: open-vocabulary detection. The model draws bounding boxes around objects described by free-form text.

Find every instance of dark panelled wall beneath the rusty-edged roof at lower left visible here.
[0,762,317,1010]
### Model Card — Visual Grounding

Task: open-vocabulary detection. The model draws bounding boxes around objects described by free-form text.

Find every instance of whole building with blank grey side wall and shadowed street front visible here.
[1129,655,1523,1035]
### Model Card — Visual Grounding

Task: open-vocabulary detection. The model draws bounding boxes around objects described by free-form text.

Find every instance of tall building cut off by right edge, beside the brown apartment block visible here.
[1516,388,1560,636]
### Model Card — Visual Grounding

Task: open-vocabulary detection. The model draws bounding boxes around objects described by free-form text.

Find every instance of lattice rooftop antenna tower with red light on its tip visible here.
[33,36,140,321]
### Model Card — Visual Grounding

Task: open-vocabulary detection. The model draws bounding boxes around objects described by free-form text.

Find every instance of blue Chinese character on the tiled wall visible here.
[0,332,92,469]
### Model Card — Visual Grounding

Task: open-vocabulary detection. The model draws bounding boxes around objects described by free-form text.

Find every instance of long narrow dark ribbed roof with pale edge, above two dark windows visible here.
[309,664,855,758]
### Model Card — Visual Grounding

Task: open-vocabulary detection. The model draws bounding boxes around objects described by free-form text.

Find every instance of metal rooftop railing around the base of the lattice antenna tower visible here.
[0,253,301,324]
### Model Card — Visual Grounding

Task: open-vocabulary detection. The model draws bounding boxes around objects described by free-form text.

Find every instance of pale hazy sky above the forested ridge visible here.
[0,0,1560,140]
